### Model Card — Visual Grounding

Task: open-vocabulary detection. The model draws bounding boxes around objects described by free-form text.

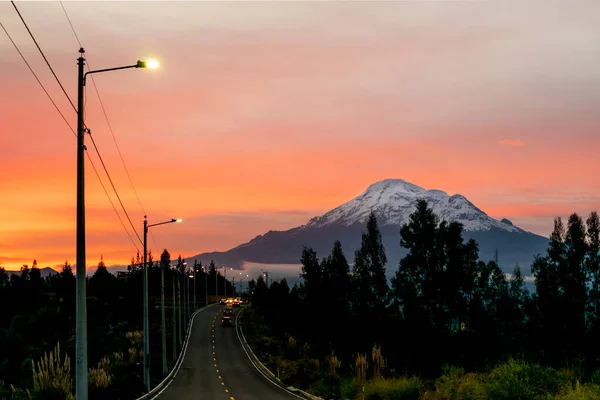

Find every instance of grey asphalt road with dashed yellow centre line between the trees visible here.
[157,305,298,400]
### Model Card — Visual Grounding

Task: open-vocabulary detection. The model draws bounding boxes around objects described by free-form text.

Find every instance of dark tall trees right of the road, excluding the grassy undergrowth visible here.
[249,200,600,378]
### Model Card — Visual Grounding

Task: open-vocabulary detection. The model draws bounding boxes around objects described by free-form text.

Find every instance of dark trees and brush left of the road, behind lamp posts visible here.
[0,249,234,399]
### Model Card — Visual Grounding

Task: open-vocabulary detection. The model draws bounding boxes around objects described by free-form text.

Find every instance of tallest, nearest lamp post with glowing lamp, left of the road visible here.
[75,47,158,400]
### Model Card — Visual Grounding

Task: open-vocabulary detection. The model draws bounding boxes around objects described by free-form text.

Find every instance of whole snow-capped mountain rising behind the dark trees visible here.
[188,179,548,276]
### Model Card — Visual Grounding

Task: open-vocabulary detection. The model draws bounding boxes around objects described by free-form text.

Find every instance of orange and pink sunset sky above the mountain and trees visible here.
[0,1,600,269]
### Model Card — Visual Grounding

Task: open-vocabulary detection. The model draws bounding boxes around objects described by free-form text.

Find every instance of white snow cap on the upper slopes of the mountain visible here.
[302,179,524,233]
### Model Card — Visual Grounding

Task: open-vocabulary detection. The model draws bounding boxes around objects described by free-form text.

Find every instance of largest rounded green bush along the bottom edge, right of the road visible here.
[486,359,567,400]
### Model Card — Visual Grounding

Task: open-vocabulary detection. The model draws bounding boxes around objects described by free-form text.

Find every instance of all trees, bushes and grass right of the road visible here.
[243,201,600,400]
